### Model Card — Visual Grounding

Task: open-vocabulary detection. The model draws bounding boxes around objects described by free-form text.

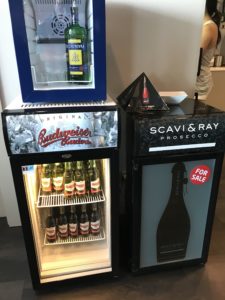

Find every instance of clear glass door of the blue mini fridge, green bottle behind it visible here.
[23,0,95,90]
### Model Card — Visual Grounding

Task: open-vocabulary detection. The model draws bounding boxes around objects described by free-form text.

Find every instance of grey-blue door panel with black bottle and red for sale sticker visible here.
[140,159,216,268]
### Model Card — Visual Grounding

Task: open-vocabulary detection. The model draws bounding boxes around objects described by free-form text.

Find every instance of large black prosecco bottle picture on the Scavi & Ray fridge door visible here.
[157,162,190,262]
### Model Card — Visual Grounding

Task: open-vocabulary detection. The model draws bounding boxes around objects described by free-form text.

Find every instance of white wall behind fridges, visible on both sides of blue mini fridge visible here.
[0,0,205,226]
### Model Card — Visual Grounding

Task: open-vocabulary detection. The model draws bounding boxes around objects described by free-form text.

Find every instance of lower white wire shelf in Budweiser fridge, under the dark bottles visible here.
[44,228,105,246]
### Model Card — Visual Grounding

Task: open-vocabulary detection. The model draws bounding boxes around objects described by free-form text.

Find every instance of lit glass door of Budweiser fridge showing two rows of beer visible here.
[22,158,112,283]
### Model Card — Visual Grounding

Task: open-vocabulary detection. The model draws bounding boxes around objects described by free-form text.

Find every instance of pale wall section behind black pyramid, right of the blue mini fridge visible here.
[106,0,205,97]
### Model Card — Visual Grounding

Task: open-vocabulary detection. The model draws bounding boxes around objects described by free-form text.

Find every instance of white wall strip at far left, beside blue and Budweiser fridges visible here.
[0,0,21,226]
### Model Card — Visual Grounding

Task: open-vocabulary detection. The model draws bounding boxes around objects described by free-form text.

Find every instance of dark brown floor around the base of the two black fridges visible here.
[0,162,225,300]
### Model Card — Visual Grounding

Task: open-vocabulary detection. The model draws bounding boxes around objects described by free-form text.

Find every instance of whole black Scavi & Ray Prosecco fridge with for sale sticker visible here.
[124,98,225,273]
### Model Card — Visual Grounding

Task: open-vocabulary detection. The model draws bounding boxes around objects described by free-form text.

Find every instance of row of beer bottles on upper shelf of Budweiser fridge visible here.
[41,160,101,198]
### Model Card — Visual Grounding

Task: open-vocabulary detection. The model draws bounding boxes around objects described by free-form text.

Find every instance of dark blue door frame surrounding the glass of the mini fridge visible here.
[9,0,106,102]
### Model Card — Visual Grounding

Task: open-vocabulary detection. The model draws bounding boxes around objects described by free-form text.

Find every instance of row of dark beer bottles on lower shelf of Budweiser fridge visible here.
[46,203,101,243]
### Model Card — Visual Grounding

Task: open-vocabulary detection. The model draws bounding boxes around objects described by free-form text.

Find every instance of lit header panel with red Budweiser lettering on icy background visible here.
[6,111,118,154]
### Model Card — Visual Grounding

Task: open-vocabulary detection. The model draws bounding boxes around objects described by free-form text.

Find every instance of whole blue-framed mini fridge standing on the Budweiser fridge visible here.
[9,0,106,102]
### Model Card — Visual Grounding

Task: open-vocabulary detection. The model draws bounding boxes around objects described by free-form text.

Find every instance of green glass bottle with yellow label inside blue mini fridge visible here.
[65,0,90,83]
